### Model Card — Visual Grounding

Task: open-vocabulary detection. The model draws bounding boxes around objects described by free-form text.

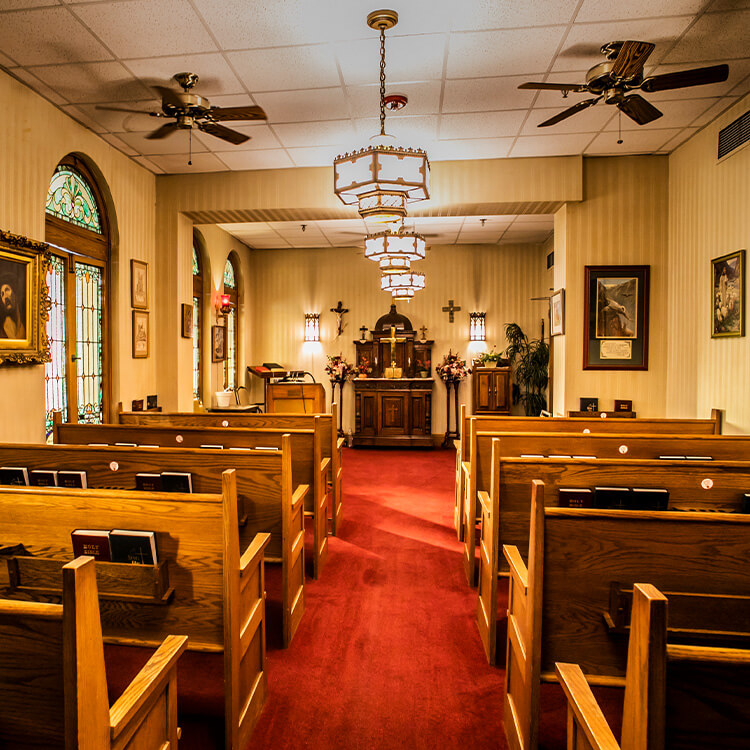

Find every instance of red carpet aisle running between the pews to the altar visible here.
[251,450,505,750]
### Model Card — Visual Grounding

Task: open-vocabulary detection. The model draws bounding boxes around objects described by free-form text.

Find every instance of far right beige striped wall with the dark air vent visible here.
[666,97,750,432]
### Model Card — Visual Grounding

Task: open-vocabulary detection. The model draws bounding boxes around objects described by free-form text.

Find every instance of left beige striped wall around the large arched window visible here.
[0,67,157,442]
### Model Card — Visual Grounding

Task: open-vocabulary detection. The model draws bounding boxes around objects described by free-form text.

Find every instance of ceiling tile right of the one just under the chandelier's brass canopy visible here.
[446,26,565,78]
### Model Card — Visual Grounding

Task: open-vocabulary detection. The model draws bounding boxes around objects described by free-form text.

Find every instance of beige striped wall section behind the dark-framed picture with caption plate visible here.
[554,156,672,417]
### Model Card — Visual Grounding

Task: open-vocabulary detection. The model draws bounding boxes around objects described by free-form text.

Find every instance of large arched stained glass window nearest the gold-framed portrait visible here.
[44,155,110,440]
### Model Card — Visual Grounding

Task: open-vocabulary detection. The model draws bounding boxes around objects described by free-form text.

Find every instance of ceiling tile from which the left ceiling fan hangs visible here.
[124,52,244,97]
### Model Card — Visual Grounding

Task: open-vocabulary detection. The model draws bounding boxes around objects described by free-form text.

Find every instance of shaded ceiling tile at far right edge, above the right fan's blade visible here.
[664,9,750,63]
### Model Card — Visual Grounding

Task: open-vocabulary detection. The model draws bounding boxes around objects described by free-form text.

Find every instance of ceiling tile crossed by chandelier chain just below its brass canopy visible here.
[335,34,446,86]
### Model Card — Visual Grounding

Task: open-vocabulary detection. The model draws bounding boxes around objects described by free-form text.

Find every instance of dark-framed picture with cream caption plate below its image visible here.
[583,266,651,370]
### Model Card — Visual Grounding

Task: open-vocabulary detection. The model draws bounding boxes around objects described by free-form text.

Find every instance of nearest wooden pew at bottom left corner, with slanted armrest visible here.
[0,557,187,750]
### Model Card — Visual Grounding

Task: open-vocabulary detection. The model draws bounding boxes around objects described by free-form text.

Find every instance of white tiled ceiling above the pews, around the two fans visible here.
[0,0,750,178]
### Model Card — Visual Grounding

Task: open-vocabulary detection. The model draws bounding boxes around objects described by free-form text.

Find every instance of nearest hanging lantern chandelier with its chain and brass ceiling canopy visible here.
[333,10,430,222]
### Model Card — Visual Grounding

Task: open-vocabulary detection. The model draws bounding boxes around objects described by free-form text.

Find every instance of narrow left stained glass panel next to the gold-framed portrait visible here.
[44,255,68,443]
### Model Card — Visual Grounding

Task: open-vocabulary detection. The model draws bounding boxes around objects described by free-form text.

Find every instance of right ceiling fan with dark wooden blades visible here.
[518,40,729,128]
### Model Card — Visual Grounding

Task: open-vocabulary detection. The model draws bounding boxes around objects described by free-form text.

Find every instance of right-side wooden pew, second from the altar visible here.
[463,428,750,585]
